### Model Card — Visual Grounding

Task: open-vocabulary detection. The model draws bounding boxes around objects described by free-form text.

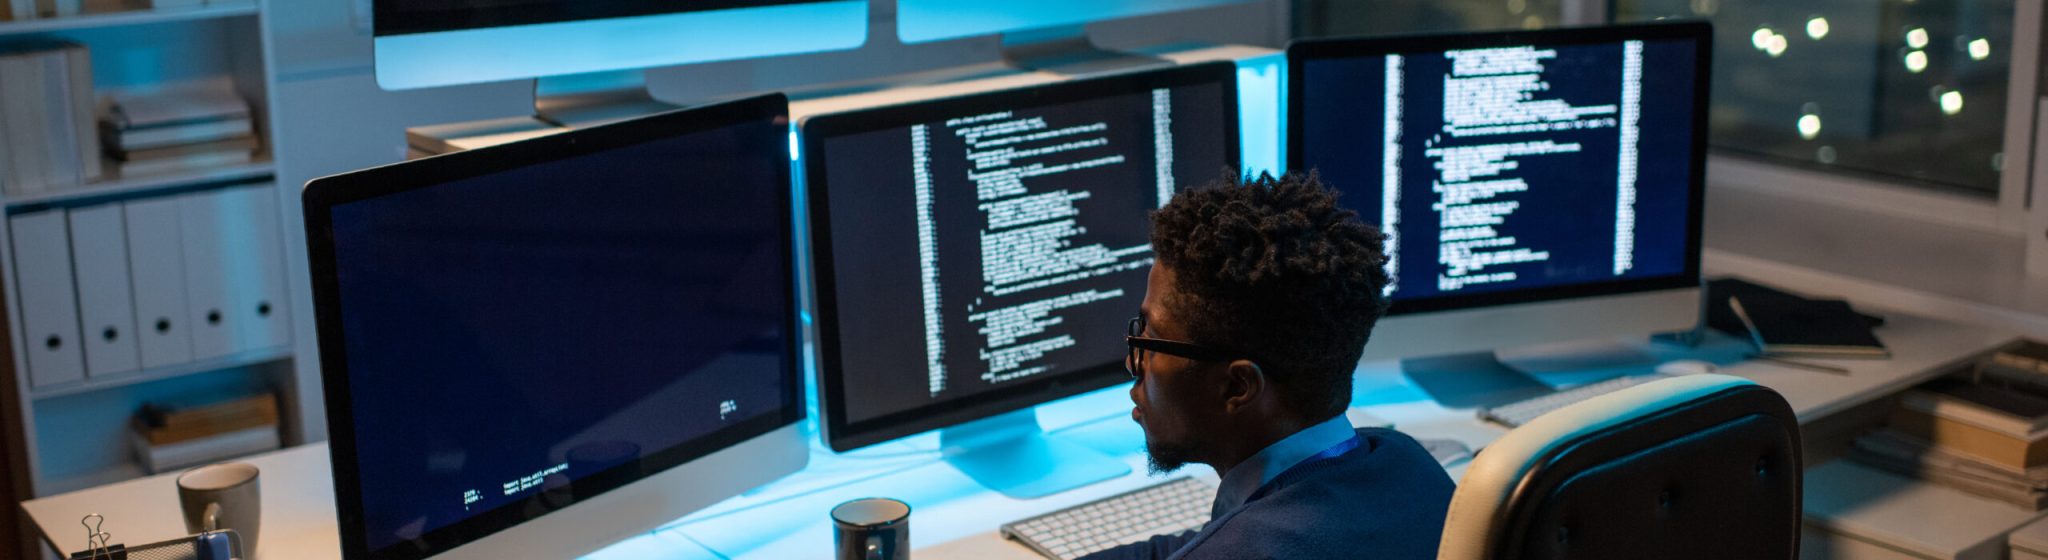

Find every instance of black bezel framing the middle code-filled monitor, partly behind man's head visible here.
[803,62,1241,451]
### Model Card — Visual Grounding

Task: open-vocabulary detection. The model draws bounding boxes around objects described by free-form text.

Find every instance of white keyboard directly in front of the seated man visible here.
[1001,476,1217,560]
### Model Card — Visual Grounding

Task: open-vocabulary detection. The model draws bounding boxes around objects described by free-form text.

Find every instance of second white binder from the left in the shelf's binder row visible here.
[72,205,141,375]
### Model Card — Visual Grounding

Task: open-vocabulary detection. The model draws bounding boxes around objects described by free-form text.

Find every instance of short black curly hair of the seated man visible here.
[1151,172,1386,421]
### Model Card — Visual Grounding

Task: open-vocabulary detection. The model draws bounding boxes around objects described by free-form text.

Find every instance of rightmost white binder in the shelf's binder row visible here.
[225,185,291,351]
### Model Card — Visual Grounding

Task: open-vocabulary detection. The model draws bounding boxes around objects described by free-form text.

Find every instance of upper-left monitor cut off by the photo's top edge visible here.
[371,0,868,90]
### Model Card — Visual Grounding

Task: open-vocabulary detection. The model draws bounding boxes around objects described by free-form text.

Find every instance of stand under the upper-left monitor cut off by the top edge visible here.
[532,70,682,129]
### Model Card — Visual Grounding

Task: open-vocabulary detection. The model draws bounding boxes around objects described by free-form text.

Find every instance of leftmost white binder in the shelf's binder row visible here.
[8,209,86,388]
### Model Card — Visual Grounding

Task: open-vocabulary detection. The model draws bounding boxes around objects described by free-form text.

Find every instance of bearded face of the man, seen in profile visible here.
[1130,265,1219,474]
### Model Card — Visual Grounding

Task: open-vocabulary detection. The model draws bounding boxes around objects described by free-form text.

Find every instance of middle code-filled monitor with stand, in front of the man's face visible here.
[803,64,1237,496]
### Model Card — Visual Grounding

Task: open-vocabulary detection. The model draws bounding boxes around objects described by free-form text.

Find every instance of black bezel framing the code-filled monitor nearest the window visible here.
[1286,21,1714,316]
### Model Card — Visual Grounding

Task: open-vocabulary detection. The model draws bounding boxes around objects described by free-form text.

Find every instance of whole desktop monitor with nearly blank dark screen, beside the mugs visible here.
[305,94,809,560]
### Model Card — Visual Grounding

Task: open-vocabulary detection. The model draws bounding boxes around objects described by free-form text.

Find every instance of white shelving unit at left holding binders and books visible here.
[0,0,317,496]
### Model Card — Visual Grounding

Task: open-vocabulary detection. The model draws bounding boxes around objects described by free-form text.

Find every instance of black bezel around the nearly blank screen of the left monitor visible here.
[301,94,805,560]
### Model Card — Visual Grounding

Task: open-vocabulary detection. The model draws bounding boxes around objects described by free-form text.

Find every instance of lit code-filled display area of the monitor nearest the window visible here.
[1288,39,1706,305]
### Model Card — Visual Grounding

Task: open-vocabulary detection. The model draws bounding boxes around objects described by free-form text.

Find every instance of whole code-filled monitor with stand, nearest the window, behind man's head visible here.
[1286,23,1712,406]
